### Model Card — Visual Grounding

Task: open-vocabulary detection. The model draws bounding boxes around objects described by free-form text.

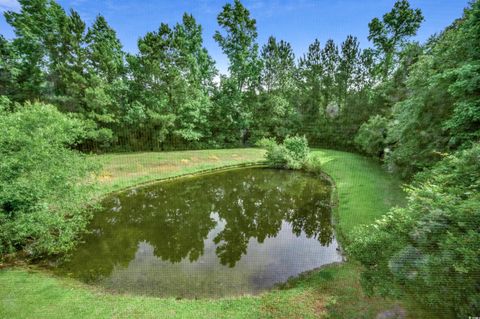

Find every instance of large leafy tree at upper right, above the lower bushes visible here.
[386,1,480,176]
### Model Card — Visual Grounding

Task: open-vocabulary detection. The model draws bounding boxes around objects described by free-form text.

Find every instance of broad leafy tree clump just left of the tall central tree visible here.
[125,14,216,148]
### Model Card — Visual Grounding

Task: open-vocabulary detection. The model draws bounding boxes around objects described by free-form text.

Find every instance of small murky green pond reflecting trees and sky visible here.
[56,168,341,298]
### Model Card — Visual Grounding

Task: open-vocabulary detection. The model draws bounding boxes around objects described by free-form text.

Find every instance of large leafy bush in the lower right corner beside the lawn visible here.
[348,144,480,318]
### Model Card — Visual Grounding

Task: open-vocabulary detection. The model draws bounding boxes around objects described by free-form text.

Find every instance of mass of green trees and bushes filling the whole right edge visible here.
[347,1,480,318]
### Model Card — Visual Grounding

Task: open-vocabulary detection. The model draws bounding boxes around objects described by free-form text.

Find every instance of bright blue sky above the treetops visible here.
[0,0,469,73]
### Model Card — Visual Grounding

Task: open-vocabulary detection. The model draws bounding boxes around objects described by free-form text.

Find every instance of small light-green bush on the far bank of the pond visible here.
[257,136,310,169]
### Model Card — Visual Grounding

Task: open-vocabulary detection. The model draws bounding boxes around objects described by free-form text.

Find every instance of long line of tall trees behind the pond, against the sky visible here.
[0,0,423,156]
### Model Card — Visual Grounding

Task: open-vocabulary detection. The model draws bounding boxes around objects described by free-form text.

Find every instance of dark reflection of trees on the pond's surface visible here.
[59,168,340,298]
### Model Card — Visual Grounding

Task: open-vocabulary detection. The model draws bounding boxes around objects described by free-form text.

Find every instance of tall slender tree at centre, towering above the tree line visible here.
[212,0,261,145]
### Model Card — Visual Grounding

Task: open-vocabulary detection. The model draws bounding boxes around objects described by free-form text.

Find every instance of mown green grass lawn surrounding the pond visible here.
[0,149,433,319]
